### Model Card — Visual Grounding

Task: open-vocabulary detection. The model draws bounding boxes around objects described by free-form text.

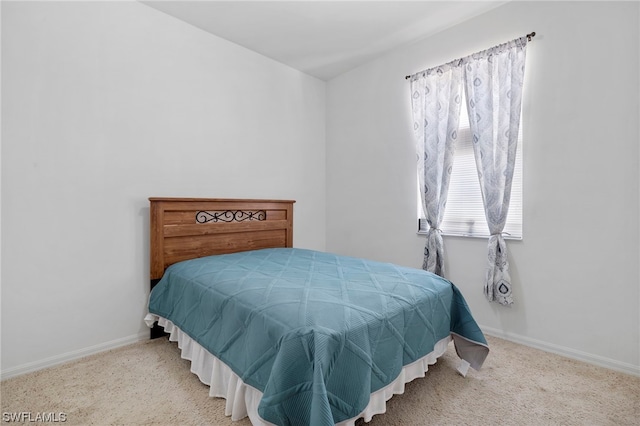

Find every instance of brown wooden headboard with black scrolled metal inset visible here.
[149,198,295,282]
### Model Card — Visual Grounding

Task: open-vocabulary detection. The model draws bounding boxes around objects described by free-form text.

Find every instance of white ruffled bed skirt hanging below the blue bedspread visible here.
[144,314,451,426]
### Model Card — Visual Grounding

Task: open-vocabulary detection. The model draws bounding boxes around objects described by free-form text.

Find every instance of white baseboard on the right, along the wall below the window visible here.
[480,325,640,377]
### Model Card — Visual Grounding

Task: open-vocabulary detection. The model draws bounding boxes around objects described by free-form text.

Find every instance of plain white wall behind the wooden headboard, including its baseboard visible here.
[2,1,326,377]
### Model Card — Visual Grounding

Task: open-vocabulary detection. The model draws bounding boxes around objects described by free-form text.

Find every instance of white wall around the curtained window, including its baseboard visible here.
[327,2,640,374]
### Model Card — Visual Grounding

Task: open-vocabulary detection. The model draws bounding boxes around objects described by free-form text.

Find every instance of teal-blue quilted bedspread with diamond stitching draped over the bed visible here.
[149,248,488,426]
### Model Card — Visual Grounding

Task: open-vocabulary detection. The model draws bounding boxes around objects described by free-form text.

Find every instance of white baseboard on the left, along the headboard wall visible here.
[0,331,149,380]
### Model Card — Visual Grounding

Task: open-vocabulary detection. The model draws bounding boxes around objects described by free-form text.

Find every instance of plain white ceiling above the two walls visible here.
[142,0,507,80]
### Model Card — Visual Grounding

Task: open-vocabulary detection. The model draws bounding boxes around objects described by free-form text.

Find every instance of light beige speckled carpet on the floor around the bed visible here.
[0,336,640,426]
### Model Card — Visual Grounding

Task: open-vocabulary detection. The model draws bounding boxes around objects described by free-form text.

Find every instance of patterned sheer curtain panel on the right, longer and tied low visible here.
[463,37,527,305]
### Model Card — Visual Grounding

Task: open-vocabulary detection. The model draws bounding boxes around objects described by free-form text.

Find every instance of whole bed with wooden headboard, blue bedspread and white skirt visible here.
[145,198,489,426]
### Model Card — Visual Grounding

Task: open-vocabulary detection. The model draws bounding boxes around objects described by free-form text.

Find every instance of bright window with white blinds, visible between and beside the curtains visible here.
[417,92,522,239]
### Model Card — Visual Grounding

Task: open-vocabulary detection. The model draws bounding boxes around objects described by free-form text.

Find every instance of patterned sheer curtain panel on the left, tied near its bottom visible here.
[411,61,462,276]
